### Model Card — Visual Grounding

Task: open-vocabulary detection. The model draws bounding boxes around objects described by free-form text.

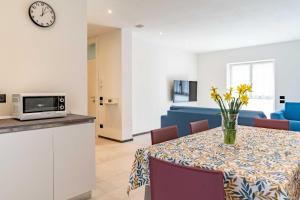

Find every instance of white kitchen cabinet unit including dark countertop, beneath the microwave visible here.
[0,115,96,200]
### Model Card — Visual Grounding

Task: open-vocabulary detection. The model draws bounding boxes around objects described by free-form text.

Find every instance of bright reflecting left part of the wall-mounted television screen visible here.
[173,80,190,102]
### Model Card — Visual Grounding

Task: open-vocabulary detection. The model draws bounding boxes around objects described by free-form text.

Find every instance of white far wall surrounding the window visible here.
[198,41,300,109]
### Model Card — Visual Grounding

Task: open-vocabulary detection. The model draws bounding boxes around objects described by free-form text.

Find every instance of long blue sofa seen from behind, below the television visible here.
[161,106,266,137]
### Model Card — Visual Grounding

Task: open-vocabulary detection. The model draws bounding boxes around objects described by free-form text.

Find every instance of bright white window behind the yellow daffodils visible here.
[227,60,275,116]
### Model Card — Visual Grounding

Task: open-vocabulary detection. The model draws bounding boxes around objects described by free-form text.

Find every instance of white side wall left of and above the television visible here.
[132,34,197,134]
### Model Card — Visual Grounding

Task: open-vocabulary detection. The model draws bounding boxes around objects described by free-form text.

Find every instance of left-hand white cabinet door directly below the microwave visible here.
[0,129,53,200]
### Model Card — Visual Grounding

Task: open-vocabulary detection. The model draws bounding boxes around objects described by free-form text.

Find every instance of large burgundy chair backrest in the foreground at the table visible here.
[149,157,224,200]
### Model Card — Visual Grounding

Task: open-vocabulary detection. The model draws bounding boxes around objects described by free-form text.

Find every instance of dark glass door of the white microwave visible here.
[23,96,59,113]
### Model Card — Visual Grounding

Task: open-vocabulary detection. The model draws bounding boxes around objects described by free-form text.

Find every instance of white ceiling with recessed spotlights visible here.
[88,0,300,52]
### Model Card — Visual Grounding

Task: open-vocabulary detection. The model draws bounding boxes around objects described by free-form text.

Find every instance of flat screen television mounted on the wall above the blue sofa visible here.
[173,80,197,103]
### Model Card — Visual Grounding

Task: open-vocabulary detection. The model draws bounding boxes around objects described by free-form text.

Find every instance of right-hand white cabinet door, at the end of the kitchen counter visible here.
[53,123,96,200]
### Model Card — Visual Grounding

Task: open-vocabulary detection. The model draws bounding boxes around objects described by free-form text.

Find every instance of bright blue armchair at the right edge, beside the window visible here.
[271,102,300,131]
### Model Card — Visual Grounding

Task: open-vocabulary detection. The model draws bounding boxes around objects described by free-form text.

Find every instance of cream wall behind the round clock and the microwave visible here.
[0,0,87,116]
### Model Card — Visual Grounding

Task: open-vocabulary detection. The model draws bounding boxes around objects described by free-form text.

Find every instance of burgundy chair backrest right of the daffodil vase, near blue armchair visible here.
[254,118,289,130]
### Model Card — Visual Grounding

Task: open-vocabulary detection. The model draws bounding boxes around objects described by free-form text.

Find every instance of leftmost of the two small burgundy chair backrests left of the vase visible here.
[151,126,178,144]
